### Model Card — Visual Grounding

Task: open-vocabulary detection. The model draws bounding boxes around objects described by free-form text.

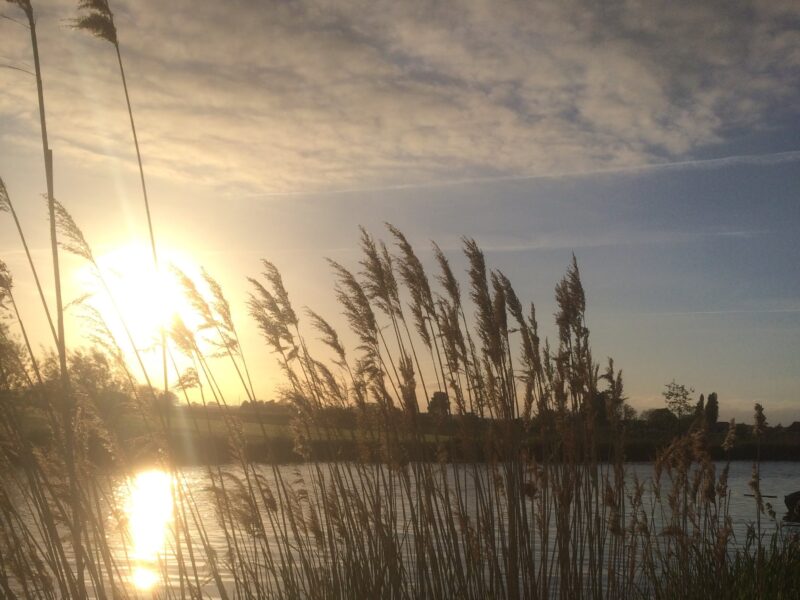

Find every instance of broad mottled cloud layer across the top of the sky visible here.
[0,0,800,193]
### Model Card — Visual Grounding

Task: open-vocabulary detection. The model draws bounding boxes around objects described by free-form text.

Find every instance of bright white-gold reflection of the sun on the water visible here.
[125,470,172,590]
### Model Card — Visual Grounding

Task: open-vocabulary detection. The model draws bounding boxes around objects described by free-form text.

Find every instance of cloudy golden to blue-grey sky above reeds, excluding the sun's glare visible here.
[0,0,800,424]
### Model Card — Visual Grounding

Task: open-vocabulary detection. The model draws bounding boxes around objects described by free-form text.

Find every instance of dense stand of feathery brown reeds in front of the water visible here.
[0,209,797,598]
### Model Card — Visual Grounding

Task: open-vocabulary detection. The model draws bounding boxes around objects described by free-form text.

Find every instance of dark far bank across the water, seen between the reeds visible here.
[14,386,800,468]
